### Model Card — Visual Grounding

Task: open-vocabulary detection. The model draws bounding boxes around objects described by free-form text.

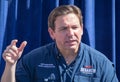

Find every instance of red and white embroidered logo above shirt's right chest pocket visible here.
[80,66,96,74]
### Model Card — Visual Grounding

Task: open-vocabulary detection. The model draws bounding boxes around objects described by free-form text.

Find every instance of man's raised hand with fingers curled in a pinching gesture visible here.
[3,40,27,65]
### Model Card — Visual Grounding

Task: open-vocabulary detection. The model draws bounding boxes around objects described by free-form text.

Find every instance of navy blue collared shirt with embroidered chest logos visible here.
[16,43,118,82]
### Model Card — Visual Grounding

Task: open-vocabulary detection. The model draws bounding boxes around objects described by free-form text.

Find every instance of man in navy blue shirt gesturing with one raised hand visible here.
[2,5,118,82]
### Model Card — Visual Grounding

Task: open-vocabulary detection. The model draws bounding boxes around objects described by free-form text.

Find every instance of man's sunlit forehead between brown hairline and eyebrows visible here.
[55,13,80,25]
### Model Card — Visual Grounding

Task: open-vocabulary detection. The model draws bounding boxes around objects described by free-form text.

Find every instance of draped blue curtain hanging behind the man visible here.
[0,0,120,80]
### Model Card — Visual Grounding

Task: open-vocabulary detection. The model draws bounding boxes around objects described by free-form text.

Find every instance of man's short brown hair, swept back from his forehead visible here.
[48,5,83,30]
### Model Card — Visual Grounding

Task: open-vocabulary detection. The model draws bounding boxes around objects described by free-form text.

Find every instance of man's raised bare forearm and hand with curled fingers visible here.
[1,40,27,82]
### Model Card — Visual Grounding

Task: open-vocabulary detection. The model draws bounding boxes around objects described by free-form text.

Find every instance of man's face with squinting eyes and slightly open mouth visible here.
[49,13,83,51]
